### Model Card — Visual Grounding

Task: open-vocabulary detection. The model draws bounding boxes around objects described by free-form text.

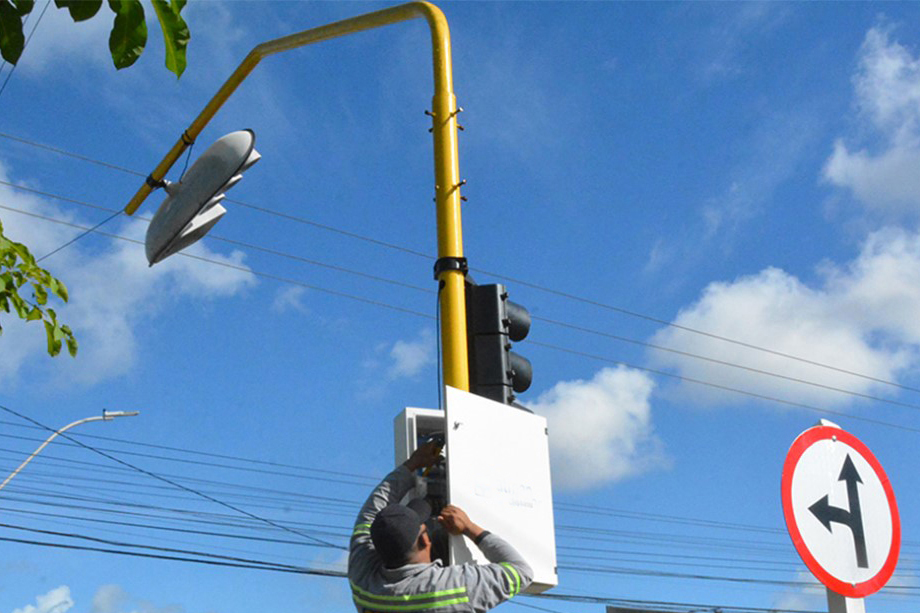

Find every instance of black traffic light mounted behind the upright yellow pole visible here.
[466,279,533,404]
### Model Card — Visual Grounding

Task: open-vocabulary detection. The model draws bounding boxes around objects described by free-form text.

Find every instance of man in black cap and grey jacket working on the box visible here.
[348,443,533,613]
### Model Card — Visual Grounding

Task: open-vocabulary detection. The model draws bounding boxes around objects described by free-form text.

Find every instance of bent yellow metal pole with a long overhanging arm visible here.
[125,2,469,391]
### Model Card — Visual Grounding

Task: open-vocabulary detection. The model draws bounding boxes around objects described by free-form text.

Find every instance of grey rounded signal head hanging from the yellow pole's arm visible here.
[144,130,262,266]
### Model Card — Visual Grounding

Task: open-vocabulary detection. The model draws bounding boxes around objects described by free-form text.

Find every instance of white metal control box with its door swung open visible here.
[394,387,559,593]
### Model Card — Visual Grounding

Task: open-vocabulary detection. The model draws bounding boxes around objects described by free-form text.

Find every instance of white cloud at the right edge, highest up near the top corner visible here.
[824,27,920,214]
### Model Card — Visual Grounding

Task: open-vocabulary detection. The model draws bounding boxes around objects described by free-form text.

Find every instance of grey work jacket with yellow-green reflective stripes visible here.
[348,466,533,613]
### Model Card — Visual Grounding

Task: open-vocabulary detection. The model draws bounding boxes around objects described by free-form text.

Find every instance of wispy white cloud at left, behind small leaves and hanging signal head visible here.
[0,160,255,384]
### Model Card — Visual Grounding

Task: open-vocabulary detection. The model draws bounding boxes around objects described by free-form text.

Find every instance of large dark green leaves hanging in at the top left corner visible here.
[0,0,190,78]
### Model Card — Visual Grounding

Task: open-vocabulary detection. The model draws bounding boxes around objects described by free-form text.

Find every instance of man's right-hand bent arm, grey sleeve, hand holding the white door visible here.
[438,505,533,612]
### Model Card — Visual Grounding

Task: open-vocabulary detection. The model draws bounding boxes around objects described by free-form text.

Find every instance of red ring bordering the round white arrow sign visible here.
[780,426,901,598]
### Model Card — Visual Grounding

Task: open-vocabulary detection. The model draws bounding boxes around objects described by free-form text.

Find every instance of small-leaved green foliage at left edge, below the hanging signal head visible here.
[0,223,77,356]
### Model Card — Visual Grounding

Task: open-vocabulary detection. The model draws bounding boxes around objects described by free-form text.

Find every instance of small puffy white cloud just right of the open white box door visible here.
[528,366,667,489]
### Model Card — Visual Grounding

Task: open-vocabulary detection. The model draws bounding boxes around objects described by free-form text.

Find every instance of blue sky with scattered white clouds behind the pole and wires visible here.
[0,2,920,613]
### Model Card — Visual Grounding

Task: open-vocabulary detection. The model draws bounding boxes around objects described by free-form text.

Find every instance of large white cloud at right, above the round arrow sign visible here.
[652,229,920,406]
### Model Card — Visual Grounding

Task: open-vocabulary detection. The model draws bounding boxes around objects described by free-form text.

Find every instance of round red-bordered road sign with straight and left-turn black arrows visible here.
[782,422,901,598]
